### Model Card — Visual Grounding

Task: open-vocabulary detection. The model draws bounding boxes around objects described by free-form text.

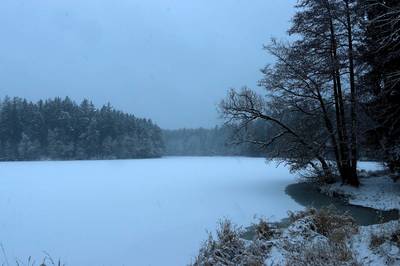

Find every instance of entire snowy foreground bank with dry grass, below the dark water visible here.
[192,207,400,266]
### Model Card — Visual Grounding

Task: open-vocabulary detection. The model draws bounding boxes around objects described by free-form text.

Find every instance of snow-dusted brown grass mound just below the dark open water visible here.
[281,207,358,266]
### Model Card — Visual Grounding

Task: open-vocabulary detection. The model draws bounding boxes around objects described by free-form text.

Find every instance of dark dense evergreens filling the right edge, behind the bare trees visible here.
[361,0,400,172]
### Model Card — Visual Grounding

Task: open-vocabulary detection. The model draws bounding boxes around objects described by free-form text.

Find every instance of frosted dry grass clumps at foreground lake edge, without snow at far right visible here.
[192,207,358,266]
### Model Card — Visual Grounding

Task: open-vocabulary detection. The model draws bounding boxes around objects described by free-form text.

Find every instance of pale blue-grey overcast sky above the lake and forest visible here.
[0,0,295,128]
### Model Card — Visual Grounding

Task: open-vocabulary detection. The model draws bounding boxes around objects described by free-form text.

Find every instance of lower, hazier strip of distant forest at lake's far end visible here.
[163,123,267,157]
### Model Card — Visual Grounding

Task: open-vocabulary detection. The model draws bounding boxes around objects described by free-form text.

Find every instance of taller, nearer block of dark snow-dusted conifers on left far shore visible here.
[0,97,164,161]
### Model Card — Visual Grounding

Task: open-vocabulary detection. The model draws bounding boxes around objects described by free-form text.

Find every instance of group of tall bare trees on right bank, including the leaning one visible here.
[221,0,366,186]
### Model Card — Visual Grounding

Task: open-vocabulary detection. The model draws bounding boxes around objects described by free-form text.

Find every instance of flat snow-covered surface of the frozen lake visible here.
[0,157,303,266]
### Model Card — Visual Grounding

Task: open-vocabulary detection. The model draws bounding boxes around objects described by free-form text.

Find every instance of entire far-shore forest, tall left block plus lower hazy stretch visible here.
[0,97,268,161]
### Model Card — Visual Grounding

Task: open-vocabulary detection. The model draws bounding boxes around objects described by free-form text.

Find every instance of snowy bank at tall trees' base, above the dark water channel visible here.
[320,175,400,210]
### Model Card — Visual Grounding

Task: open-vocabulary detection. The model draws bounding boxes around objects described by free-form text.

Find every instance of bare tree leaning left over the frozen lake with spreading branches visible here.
[220,88,332,179]
